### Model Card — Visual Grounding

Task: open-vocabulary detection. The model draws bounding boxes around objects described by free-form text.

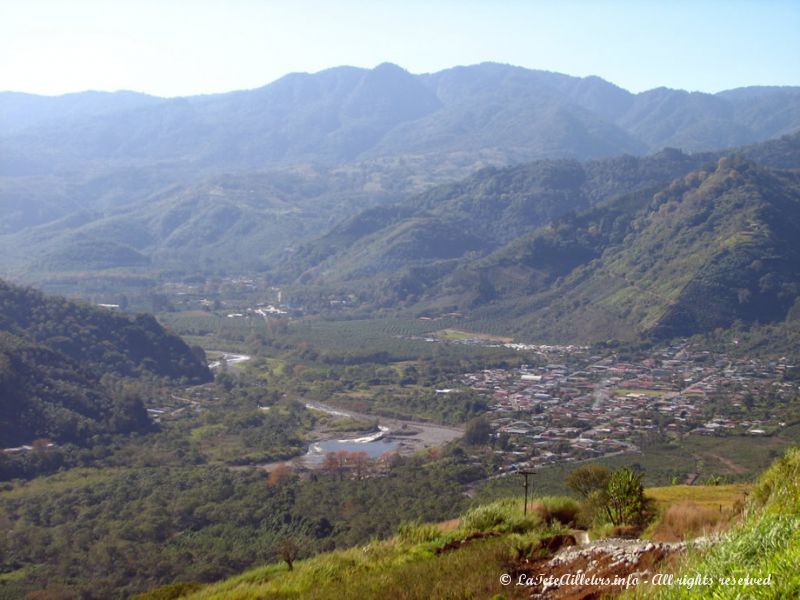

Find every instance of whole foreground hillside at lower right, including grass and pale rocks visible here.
[145,450,800,600]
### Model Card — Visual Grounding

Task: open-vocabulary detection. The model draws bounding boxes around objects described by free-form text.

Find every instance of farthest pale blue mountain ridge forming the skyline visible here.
[6,63,800,174]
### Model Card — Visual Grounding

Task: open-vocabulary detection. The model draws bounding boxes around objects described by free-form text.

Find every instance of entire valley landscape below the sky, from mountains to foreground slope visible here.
[0,52,800,600]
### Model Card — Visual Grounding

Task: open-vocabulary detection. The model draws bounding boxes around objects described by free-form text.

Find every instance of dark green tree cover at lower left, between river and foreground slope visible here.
[0,434,485,599]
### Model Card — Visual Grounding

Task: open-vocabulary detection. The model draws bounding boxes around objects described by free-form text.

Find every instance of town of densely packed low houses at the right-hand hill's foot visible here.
[460,342,800,470]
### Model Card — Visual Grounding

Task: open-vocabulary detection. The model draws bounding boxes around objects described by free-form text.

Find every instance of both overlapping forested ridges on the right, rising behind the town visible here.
[283,134,800,340]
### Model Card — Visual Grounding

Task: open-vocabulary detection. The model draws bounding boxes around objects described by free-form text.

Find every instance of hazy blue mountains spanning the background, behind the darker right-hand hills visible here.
[0,63,800,284]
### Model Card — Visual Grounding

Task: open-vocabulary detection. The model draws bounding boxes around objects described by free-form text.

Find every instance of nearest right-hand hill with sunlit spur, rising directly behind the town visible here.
[443,159,800,340]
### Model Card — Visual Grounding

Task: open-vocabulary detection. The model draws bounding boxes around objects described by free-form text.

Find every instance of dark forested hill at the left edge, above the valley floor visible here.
[0,281,211,447]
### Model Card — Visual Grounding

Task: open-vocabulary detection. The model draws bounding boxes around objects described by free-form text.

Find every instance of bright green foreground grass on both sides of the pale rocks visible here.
[141,449,800,600]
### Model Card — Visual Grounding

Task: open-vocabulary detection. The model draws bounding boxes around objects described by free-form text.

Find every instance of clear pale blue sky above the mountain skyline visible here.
[0,0,800,96]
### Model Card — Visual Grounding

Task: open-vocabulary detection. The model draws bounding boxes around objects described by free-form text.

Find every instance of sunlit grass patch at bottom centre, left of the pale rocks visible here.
[161,498,571,600]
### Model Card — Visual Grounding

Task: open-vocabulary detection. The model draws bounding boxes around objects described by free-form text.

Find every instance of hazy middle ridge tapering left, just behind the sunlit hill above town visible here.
[276,150,708,283]
